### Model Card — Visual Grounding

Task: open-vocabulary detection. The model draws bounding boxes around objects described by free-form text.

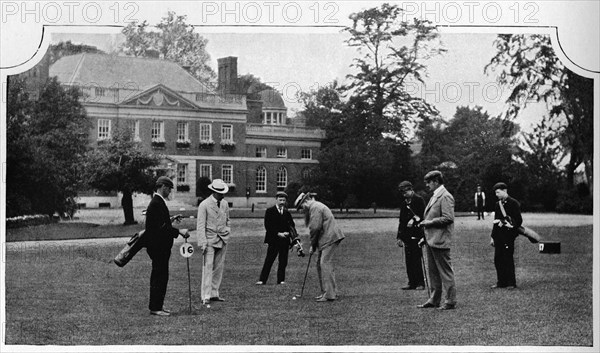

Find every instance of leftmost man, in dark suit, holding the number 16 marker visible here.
[144,176,190,316]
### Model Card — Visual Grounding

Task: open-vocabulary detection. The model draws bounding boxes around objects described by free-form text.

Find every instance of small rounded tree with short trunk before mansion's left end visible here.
[84,127,161,225]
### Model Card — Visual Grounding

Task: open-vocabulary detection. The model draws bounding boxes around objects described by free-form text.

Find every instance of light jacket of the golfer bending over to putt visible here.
[308,201,344,250]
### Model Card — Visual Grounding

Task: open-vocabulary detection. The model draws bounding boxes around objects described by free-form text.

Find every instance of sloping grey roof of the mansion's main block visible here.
[50,53,212,93]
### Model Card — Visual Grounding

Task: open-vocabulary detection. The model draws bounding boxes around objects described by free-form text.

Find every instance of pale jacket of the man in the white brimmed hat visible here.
[196,195,231,248]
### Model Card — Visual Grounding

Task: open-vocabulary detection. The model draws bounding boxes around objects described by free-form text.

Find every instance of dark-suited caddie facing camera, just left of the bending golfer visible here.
[256,192,295,285]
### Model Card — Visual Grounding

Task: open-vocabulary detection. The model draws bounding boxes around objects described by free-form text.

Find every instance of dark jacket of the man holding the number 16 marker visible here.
[144,195,179,251]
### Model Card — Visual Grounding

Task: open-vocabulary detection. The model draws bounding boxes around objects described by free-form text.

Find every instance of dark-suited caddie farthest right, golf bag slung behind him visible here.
[490,183,523,289]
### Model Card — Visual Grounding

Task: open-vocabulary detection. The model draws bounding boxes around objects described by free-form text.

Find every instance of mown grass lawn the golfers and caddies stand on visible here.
[5,214,593,347]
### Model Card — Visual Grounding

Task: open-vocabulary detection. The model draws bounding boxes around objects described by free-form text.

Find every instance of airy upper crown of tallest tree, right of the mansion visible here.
[344,3,445,139]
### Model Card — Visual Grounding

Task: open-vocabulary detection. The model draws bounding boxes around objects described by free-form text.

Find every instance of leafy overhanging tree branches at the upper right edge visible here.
[485,34,594,193]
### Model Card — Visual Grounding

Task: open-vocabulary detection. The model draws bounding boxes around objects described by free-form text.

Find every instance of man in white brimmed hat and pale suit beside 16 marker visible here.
[196,179,231,304]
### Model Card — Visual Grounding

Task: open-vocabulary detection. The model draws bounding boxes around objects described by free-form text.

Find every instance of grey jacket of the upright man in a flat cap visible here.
[424,185,454,249]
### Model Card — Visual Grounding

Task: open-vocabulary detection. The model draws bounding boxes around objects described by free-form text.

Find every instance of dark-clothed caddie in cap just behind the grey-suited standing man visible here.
[396,181,425,290]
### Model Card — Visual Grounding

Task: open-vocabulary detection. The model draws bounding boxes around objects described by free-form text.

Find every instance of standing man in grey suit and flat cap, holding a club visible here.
[417,170,456,310]
